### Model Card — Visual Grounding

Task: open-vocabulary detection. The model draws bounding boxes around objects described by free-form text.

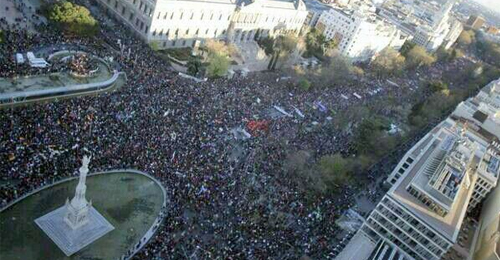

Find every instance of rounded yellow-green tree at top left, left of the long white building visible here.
[48,2,98,36]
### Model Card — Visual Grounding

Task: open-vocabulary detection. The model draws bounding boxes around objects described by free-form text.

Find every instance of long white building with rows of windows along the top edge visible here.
[98,0,307,49]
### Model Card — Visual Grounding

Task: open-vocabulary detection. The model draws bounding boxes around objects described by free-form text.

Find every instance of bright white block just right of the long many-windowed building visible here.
[316,3,406,60]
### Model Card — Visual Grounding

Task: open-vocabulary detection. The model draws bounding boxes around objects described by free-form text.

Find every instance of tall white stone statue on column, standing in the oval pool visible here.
[64,155,92,230]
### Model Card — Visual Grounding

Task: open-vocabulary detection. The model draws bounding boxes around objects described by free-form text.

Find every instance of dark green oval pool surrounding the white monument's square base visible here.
[0,170,166,260]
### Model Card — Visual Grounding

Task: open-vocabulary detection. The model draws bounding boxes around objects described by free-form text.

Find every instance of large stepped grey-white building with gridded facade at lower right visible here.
[350,79,500,260]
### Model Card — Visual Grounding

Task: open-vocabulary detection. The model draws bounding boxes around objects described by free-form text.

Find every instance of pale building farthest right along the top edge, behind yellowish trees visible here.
[377,0,463,51]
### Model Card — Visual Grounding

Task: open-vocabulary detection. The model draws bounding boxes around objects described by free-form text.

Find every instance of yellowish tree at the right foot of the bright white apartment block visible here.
[372,48,406,76]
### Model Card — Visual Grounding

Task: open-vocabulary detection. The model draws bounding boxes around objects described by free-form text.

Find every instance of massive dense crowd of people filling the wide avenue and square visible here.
[0,1,472,259]
